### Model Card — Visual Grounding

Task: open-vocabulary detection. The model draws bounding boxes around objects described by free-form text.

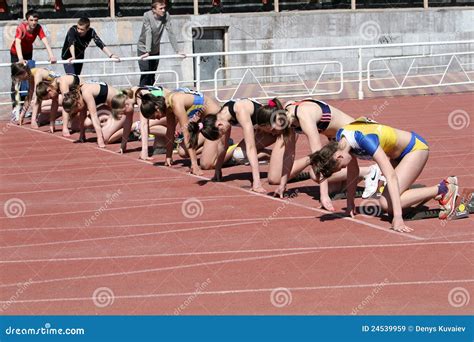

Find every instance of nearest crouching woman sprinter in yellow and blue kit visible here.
[310,118,458,232]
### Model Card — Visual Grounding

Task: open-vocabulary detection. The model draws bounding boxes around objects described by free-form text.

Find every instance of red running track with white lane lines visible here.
[0,94,474,315]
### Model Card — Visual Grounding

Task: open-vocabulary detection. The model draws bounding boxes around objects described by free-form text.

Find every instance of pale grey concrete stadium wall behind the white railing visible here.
[0,7,474,97]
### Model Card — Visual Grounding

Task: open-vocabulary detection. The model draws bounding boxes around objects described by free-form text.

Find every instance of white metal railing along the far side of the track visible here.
[0,40,474,104]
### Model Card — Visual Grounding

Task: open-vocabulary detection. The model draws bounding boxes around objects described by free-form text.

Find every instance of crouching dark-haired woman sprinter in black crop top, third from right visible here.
[188,99,276,193]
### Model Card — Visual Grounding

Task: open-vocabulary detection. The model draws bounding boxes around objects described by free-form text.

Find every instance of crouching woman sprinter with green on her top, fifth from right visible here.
[112,86,169,160]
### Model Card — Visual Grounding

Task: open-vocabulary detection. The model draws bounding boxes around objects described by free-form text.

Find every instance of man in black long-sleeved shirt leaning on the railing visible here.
[61,18,120,75]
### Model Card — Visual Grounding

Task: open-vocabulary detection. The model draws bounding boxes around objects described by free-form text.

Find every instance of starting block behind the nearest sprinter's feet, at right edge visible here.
[403,188,474,221]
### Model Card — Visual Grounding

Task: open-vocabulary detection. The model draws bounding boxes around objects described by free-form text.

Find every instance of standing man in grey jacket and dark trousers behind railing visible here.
[137,0,180,87]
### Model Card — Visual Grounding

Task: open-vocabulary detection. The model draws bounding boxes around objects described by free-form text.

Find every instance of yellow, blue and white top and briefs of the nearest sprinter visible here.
[336,118,429,161]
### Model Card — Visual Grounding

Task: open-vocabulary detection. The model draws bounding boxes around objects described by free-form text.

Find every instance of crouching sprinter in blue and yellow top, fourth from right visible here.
[140,88,219,175]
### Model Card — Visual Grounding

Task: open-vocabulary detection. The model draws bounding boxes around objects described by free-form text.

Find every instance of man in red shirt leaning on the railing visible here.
[10,10,56,107]
